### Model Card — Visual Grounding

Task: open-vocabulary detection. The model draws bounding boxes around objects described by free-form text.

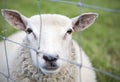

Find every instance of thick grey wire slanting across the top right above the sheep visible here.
[49,0,120,13]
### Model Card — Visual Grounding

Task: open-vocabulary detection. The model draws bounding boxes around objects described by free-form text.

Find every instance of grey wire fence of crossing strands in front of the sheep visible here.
[0,0,120,82]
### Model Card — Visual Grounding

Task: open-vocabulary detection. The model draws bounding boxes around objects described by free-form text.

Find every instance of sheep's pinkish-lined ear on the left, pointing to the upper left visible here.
[1,9,27,31]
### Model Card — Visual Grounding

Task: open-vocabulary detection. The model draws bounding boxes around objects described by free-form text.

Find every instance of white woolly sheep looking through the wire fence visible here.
[0,9,98,82]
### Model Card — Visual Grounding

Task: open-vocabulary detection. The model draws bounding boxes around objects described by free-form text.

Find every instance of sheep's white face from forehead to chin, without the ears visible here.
[27,15,73,73]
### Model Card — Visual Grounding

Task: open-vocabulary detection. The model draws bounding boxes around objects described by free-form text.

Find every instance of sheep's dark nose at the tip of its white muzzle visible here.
[43,54,59,62]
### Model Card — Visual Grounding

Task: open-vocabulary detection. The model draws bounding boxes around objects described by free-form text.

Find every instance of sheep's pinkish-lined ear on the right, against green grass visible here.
[72,13,98,32]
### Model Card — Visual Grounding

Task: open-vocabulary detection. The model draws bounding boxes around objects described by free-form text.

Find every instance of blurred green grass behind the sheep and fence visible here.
[0,0,120,82]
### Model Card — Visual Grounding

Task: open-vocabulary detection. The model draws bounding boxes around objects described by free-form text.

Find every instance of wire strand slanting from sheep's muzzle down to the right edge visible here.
[60,58,120,80]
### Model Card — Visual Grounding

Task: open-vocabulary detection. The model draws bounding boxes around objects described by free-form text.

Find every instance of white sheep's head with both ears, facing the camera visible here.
[2,9,97,74]
